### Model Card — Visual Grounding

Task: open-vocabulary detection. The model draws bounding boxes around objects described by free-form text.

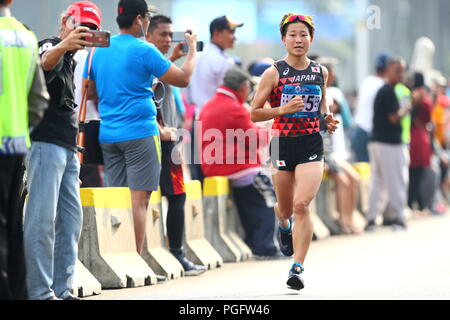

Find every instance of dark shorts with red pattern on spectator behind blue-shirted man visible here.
[160,141,185,196]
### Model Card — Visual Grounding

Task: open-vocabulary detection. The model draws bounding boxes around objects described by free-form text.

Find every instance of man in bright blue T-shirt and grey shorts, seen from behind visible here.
[84,0,197,253]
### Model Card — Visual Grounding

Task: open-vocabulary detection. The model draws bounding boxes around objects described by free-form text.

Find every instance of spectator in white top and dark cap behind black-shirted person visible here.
[351,54,389,162]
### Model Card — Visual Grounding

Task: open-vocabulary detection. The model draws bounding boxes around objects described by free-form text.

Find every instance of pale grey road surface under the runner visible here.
[86,214,450,300]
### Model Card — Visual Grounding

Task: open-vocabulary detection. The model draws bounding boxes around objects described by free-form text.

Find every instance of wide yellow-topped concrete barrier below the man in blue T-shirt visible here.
[78,188,157,289]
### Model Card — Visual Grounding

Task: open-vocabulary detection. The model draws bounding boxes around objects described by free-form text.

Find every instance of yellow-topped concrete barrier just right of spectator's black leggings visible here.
[183,181,223,270]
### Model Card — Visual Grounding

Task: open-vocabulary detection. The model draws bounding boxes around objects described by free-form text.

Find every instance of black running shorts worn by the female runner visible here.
[270,133,323,172]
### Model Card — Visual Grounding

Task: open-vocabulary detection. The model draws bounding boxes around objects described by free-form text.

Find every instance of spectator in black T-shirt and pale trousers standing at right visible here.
[366,58,410,231]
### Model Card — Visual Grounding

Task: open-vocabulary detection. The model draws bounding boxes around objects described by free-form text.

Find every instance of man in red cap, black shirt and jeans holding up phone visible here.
[24,1,101,300]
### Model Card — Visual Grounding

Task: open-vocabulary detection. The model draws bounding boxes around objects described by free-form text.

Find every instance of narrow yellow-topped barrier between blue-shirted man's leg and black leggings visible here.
[141,190,184,280]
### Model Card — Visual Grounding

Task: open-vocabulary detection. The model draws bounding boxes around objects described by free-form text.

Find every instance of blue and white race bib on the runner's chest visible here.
[281,84,322,118]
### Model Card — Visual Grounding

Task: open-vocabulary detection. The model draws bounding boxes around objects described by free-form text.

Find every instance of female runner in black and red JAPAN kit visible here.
[252,13,339,290]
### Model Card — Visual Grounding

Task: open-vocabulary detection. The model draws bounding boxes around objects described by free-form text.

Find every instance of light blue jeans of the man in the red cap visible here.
[24,142,83,300]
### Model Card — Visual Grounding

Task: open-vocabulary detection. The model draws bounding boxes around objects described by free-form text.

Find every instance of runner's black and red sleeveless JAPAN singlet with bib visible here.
[269,60,324,137]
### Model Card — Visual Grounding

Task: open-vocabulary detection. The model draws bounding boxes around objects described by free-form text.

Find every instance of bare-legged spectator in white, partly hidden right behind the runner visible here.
[317,57,361,234]
